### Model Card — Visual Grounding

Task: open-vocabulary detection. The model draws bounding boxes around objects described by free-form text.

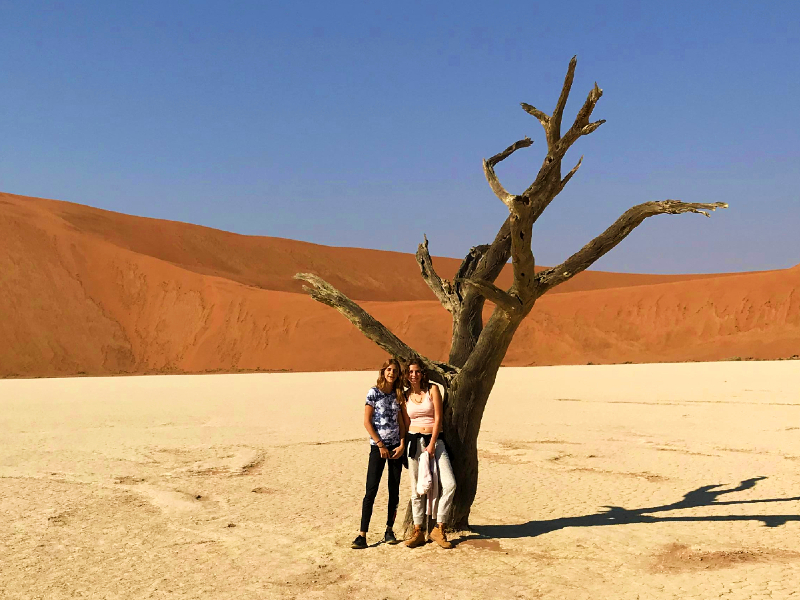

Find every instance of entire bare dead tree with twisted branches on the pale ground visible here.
[295,57,727,529]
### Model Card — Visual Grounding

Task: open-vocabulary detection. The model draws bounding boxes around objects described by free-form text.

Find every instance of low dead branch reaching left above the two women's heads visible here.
[294,273,459,387]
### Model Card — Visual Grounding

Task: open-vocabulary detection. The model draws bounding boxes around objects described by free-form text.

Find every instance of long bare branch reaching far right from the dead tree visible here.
[536,200,728,297]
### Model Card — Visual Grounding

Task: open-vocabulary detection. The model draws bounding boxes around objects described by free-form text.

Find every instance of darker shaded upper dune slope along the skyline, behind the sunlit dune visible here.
[7,194,732,301]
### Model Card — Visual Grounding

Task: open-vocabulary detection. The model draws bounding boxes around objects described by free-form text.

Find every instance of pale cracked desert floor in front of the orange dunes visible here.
[0,361,800,600]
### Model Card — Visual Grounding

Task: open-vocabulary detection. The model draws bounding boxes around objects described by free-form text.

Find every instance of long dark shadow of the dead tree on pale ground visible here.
[472,477,800,539]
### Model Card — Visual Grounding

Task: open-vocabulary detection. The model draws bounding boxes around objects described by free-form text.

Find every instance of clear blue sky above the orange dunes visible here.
[0,0,800,273]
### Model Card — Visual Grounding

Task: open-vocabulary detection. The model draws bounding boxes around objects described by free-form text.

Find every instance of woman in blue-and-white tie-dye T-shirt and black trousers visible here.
[352,358,406,549]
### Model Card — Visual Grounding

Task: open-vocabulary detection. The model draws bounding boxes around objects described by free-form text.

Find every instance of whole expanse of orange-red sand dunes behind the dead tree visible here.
[0,193,800,377]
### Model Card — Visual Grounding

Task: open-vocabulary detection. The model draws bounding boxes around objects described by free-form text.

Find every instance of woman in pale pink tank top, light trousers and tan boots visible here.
[403,359,456,548]
